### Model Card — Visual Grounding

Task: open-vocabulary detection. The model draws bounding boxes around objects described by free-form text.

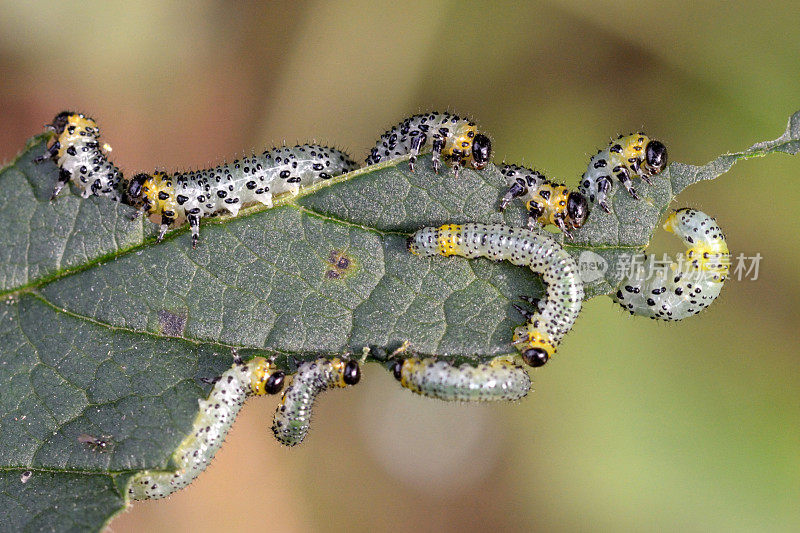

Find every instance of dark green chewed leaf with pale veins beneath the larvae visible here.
[0,113,800,529]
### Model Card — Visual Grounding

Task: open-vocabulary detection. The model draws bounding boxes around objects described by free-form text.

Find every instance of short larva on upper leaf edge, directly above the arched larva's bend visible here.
[500,165,589,238]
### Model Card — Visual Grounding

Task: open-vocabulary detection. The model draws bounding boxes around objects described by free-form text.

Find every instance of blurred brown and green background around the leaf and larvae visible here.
[0,0,800,532]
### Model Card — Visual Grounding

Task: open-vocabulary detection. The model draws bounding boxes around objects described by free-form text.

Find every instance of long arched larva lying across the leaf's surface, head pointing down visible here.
[408,224,583,366]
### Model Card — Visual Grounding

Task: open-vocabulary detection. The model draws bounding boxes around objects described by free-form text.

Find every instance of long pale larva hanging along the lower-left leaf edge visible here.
[128,353,284,500]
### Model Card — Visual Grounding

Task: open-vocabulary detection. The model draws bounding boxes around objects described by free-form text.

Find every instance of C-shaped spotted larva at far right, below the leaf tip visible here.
[613,208,730,320]
